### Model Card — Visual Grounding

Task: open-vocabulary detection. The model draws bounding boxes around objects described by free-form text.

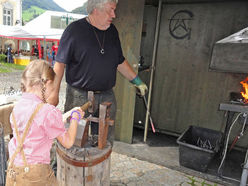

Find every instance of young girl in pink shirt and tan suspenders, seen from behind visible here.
[6,60,84,186]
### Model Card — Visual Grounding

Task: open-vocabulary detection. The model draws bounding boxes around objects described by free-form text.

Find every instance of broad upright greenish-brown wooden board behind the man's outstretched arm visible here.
[114,0,145,143]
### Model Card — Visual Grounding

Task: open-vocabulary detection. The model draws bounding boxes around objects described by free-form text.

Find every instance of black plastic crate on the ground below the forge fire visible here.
[177,126,222,172]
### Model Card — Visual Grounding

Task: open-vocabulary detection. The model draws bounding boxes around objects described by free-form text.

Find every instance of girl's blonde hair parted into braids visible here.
[21,59,55,102]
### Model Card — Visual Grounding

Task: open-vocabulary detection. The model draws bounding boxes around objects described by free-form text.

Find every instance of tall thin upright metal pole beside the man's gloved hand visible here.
[144,0,162,142]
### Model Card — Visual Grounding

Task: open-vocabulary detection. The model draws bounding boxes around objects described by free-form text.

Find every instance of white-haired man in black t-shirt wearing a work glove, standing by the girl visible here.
[51,0,147,143]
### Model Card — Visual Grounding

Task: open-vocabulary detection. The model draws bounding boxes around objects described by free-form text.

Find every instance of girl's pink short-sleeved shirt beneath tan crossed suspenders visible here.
[8,93,66,166]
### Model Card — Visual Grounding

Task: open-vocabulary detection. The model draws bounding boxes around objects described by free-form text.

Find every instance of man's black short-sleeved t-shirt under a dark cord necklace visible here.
[56,18,125,91]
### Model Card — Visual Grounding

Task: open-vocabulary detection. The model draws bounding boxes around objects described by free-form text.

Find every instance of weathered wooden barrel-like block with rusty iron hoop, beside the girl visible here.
[56,142,112,186]
